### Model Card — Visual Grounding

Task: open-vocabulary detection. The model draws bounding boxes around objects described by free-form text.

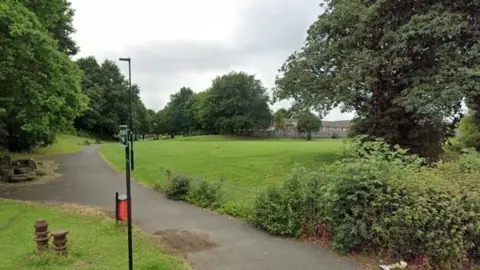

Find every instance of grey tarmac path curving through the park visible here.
[0,146,360,270]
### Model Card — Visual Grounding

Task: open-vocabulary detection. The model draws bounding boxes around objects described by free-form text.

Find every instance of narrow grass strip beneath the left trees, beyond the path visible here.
[0,134,94,158]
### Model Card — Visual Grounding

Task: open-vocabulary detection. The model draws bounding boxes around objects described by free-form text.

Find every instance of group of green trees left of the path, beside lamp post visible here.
[0,0,155,152]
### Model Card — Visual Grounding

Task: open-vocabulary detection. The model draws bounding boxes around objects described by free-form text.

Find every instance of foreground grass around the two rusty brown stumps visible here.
[0,200,189,270]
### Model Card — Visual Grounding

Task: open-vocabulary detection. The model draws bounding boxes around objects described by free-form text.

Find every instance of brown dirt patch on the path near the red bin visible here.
[153,229,217,255]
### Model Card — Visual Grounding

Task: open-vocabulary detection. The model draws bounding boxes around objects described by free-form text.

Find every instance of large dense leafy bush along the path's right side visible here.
[251,138,480,269]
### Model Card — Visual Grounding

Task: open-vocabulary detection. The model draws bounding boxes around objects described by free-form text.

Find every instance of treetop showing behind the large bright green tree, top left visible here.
[22,0,79,55]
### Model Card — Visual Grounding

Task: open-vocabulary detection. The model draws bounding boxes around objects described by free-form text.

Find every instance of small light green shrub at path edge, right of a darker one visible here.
[186,180,223,209]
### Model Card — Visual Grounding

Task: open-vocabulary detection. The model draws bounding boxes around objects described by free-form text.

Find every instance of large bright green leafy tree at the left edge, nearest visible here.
[0,0,87,151]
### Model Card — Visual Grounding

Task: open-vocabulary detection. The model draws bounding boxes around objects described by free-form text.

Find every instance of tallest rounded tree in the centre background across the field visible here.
[204,72,272,134]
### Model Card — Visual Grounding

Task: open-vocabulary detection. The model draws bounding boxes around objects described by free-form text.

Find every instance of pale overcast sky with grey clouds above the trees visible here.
[71,0,352,120]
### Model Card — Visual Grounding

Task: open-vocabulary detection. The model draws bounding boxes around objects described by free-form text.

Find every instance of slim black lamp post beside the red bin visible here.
[119,57,133,270]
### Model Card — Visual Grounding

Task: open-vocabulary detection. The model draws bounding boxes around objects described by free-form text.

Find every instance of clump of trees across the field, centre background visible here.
[152,72,272,138]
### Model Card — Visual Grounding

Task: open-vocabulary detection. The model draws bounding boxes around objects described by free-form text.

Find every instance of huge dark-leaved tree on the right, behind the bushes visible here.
[274,0,480,160]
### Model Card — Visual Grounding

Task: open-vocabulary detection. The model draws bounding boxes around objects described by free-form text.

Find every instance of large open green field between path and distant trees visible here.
[101,136,343,216]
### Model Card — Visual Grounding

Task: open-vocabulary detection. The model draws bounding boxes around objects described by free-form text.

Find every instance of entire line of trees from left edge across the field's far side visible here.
[0,0,320,152]
